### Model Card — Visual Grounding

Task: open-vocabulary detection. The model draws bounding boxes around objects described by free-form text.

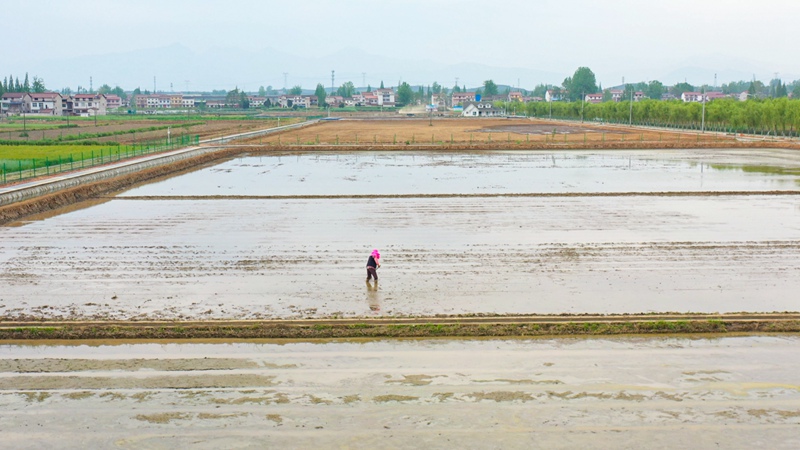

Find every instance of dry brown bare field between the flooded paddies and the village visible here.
[250,118,735,145]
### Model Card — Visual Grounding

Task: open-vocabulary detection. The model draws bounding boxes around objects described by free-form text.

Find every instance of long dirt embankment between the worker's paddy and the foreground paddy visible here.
[0,314,800,340]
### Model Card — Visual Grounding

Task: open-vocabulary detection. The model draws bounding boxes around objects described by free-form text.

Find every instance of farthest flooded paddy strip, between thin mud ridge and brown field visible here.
[124,151,800,196]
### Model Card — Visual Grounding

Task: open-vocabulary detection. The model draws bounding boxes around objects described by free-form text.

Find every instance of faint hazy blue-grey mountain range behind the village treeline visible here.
[26,44,800,91]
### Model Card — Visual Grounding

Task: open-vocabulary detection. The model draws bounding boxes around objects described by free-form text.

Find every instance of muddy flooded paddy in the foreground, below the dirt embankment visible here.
[0,336,800,449]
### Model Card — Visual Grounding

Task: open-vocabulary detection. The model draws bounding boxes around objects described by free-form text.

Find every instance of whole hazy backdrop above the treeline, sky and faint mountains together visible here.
[6,0,800,90]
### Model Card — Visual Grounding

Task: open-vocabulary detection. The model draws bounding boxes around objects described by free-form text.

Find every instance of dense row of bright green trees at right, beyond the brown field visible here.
[506,98,800,136]
